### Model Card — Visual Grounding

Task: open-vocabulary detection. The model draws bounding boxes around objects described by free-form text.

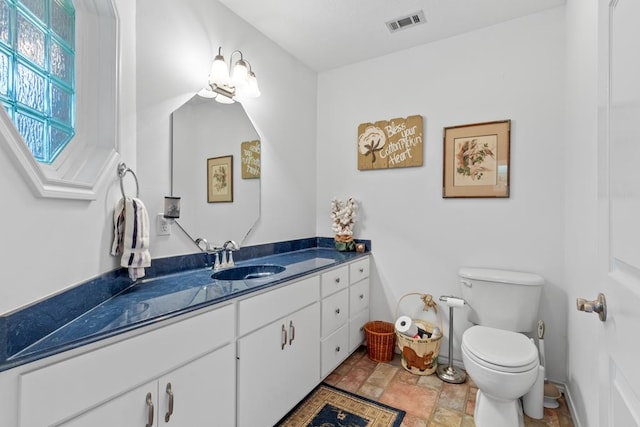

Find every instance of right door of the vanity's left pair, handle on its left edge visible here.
[157,344,236,427]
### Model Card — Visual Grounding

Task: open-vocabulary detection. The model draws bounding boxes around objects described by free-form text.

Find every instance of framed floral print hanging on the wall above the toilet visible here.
[442,120,511,198]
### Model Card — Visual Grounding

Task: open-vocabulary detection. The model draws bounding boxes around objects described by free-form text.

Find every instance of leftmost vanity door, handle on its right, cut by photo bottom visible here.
[57,381,158,427]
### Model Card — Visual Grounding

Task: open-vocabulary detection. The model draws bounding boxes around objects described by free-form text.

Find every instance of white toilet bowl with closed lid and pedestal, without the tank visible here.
[462,326,539,427]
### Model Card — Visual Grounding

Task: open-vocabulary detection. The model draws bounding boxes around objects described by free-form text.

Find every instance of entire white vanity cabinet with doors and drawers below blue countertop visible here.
[0,257,369,427]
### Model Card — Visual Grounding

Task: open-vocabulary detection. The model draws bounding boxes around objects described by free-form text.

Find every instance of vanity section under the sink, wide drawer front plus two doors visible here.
[237,276,320,427]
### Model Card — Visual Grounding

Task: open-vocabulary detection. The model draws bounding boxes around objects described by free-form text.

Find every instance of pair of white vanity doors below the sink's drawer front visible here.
[237,302,320,427]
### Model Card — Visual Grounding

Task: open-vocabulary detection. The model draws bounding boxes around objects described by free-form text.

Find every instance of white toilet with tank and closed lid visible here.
[458,268,544,427]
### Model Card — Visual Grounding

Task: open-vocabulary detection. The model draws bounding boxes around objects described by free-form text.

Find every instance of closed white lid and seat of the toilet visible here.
[462,326,538,372]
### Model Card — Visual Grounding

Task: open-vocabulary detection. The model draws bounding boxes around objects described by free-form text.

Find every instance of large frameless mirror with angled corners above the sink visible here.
[171,95,260,247]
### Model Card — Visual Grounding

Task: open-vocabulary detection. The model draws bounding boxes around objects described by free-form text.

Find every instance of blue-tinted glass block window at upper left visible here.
[0,0,75,163]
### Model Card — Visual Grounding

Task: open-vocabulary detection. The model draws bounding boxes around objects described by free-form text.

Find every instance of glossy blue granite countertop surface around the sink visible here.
[0,239,366,371]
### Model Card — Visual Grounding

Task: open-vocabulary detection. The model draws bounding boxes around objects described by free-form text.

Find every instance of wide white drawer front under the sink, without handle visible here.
[238,276,320,335]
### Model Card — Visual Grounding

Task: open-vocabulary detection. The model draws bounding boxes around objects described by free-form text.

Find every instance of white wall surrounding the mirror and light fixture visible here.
[137,0,317,257]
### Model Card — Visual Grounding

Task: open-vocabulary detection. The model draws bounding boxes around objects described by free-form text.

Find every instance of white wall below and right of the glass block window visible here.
[0,0,136,313]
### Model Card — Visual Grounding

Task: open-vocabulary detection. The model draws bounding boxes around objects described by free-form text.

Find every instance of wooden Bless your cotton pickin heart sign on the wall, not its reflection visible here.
[358,116,423,170]
